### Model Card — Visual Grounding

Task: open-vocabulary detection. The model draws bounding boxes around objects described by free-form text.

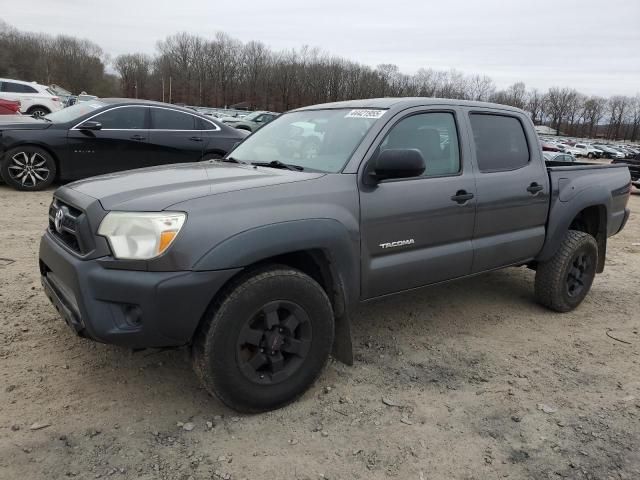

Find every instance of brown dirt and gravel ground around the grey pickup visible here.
[0,186,640,480]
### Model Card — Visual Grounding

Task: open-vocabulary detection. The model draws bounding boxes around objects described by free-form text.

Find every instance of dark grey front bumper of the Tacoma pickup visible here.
[40,231,239,348]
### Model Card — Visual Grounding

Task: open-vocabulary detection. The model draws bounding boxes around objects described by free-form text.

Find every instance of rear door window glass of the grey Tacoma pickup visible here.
[470,113,529,172]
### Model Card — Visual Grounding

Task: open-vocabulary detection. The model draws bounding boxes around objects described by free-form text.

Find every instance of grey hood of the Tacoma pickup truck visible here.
[67,160,324,211]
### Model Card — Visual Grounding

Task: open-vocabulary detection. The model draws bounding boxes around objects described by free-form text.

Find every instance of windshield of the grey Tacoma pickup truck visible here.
[230,109,385,173]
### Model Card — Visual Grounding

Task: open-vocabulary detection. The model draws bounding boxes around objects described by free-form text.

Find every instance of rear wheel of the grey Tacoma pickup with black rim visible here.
[535,230,598,312]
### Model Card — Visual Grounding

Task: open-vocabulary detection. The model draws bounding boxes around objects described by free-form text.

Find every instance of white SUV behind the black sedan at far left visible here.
[0,78,64,117]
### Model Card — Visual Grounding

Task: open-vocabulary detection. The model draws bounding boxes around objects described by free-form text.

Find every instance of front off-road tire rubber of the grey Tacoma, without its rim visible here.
[191,265,334,413]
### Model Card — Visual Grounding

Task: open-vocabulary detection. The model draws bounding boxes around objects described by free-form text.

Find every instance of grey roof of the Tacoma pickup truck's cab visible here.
[296,97,522,112]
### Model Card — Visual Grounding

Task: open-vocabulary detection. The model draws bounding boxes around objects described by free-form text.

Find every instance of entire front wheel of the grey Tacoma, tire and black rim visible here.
[192,266,334,412]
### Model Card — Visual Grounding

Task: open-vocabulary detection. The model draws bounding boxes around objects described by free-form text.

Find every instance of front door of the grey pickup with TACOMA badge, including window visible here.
[360,109,476,299]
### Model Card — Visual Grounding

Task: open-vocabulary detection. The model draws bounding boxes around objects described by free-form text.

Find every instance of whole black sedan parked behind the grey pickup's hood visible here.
[0,98,247,190]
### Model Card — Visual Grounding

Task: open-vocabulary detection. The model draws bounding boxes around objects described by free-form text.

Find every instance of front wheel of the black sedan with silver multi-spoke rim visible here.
[0,145,56,191]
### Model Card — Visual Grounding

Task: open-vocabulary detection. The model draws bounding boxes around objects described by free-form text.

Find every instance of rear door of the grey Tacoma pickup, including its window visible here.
[468,110,549,273]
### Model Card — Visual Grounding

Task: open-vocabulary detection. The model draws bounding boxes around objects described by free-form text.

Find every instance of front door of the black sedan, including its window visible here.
[65,105,149,178]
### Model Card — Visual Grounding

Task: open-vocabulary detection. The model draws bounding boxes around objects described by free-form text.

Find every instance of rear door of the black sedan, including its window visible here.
[149,107,206,165]
